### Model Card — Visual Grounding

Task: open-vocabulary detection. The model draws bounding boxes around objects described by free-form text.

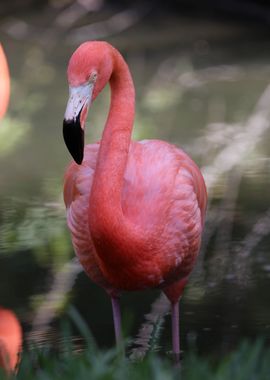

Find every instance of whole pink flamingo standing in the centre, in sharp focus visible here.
[63,41,207,360]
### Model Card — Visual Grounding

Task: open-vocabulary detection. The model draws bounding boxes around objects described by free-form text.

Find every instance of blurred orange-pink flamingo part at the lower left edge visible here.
[0,307,22,373]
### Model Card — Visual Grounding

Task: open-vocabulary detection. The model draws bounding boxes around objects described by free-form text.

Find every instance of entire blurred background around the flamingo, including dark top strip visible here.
[0,0,270,355]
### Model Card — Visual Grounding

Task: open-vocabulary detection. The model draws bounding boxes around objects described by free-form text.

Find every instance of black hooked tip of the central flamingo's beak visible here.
[63,118,84,165]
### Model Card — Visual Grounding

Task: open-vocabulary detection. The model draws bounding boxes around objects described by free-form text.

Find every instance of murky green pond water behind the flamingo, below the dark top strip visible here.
[0,5,270,352]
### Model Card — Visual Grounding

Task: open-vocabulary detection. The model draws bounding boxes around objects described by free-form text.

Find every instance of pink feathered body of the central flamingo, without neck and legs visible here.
[64,140,206,291]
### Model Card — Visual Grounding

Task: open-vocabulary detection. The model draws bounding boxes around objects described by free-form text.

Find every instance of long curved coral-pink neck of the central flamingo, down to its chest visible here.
[89,51,147,271]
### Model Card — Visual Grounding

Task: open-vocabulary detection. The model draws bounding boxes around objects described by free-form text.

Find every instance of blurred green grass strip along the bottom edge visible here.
[0,340,270,380]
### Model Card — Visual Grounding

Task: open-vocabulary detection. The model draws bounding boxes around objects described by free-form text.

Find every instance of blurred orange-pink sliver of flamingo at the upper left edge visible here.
[0,44,10,119]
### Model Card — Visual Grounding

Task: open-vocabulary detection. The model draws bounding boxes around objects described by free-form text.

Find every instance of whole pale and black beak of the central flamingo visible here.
[63,83,93,165]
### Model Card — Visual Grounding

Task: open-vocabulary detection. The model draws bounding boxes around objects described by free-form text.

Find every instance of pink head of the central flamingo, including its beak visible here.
[63,41,113,164]
